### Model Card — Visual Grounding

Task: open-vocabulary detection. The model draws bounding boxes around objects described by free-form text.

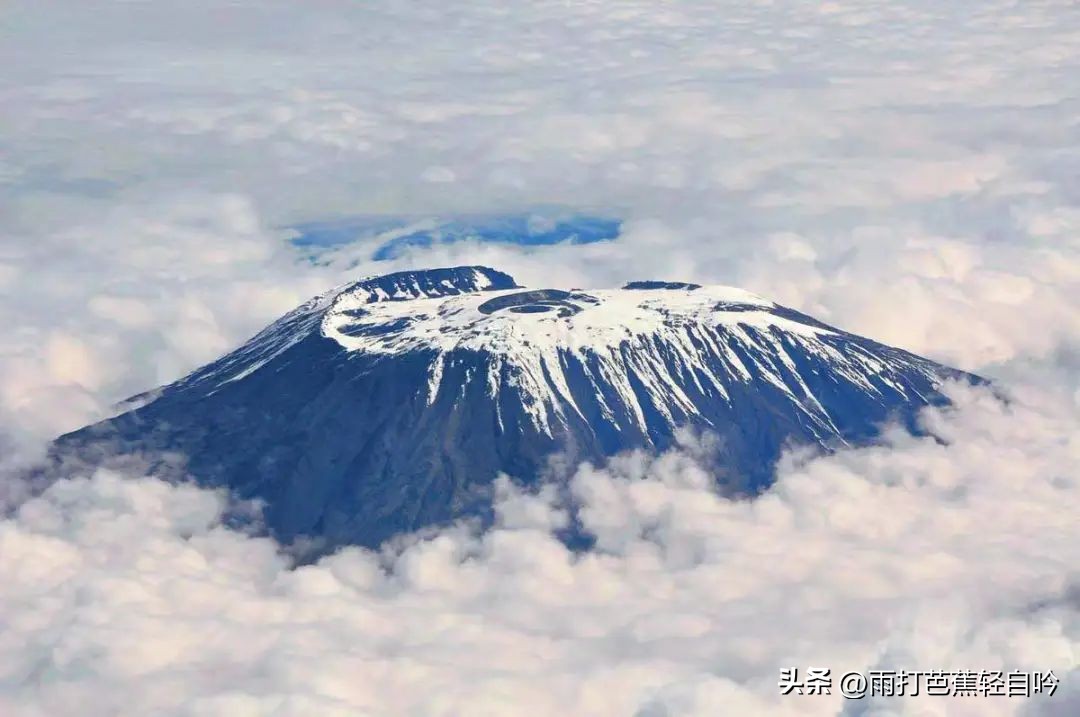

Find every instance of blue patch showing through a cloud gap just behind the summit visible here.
[289,213,622,261]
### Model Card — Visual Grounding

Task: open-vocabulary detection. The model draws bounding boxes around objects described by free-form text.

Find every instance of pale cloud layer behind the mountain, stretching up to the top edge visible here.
[0,0,1080,436]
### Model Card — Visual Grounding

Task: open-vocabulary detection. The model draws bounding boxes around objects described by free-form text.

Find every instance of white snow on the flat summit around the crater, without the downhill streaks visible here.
[322,268,833,353]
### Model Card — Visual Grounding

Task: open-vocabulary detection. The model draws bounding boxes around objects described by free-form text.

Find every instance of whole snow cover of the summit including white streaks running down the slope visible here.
[322,268,940,438]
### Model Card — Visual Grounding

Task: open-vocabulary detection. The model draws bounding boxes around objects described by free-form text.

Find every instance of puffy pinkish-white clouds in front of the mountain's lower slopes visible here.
[0,384,1080,717]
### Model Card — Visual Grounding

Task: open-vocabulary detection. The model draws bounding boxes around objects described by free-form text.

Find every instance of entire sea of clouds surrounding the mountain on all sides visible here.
[0,0,1080,717]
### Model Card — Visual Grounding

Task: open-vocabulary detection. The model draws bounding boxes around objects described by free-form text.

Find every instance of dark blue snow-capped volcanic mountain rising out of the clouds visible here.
[57,267,978,545]
